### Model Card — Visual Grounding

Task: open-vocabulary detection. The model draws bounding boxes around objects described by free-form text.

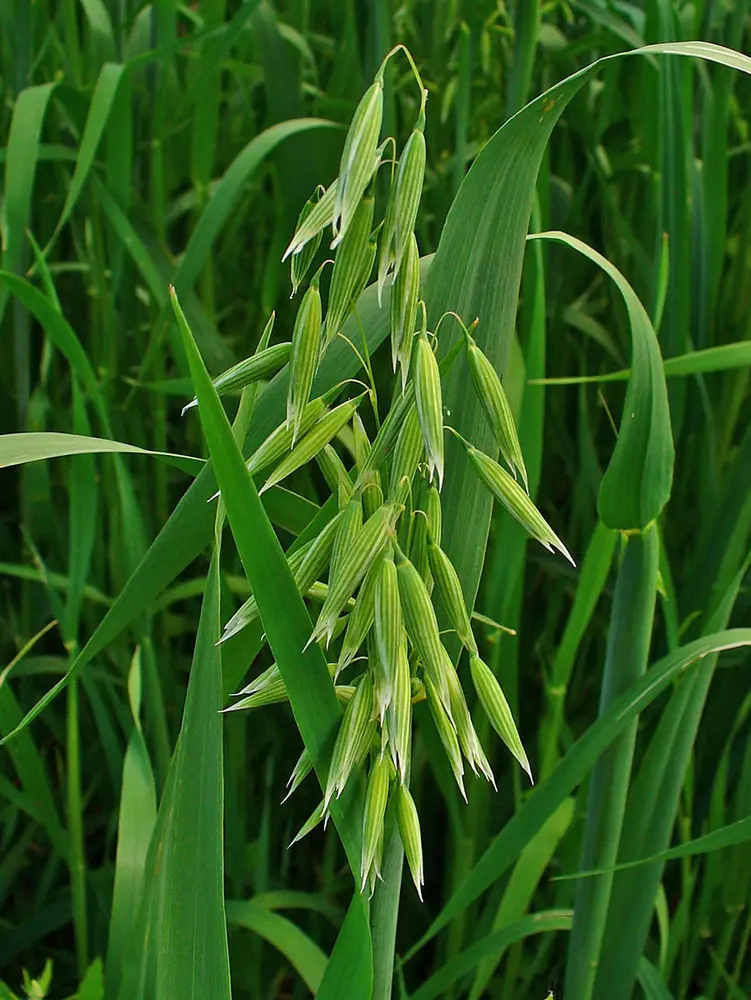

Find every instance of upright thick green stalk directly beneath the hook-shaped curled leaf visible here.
[565,524,659,1000]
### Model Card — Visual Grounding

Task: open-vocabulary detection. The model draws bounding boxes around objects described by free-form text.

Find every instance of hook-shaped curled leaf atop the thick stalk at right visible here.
[532,233,675,531]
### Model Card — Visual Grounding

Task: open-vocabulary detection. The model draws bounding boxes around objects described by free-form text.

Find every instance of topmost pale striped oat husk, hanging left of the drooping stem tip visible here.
[332,72,383,247]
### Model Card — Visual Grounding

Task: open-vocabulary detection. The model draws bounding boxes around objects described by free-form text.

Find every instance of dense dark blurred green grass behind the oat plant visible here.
[0,0,751,1000]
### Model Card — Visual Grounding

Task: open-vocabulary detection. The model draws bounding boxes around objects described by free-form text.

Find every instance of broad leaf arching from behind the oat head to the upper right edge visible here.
[425,35,751,628]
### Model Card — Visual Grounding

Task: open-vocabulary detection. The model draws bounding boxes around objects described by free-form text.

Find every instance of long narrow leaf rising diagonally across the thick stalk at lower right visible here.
[406,628,751,958]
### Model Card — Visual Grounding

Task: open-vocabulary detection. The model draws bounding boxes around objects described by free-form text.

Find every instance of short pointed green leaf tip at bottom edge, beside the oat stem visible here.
[316,892,373,1000]
